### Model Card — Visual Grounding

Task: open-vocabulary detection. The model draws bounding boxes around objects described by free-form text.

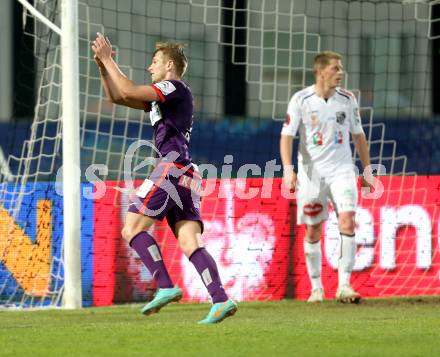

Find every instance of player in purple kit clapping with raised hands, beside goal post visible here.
[92,33,237,324]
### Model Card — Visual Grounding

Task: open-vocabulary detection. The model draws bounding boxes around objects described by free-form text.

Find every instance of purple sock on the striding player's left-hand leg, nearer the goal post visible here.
[130,232,173,289]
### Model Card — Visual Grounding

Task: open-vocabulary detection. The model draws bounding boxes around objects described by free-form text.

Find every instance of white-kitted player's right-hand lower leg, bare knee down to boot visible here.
[336,212,361,303]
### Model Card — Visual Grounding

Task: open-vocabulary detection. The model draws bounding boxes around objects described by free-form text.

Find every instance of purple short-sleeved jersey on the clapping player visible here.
[145,80,193,166]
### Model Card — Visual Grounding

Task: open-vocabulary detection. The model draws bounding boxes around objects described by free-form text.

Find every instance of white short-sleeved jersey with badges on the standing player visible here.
[281,85,363,177]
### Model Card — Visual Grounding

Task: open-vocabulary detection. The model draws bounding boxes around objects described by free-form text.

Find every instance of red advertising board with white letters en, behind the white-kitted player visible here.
[293,176,440,299]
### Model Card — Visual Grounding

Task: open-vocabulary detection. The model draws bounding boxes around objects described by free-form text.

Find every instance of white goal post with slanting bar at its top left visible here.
[18,0,82,309]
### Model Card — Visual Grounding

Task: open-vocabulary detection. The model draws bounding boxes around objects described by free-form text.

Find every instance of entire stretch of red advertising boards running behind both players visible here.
[93,176,440,305]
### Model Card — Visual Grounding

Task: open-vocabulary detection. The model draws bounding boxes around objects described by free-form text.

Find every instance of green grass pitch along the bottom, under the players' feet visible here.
[0,298,440,357]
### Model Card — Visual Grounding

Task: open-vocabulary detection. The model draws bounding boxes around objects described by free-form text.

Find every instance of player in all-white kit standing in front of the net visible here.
[280,51,371,302]
